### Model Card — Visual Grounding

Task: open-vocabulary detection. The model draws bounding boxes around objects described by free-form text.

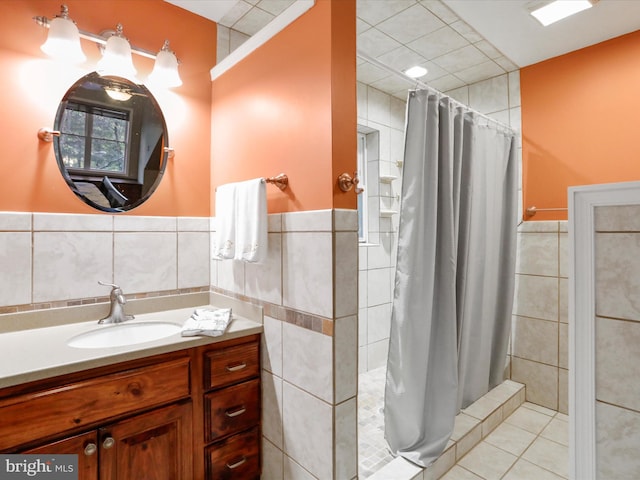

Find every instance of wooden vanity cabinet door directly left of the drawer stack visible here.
[100,403,193,480]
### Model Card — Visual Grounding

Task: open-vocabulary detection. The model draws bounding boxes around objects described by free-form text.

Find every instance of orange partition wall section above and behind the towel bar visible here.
[211,0,356,214]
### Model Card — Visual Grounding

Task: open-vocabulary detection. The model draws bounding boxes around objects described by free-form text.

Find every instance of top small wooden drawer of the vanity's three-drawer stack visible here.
[204,342,260,389]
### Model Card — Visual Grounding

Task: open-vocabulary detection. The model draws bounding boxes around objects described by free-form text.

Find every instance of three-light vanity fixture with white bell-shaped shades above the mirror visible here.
[33,5,182,88]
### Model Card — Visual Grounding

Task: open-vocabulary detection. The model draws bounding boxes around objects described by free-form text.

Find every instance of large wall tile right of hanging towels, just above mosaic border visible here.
[282,232,333,318]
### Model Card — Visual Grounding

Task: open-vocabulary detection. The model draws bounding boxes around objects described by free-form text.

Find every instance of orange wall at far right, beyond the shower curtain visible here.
[520,30,640,220]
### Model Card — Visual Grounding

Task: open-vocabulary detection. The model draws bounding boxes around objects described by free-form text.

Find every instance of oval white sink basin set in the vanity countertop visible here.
[67,322,182,348]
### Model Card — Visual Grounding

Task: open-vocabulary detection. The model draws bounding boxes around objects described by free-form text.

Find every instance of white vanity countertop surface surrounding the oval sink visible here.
[0,305,262,388]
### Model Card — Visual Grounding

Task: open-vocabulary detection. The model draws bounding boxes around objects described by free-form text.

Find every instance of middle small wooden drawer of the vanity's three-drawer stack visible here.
[205,379,260,442]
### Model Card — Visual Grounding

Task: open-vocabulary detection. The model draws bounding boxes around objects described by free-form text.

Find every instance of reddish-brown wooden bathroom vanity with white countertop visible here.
[0,300,262,480]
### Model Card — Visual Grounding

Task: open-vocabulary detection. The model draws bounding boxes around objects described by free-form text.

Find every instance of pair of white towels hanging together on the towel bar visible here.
[214,178,268,262]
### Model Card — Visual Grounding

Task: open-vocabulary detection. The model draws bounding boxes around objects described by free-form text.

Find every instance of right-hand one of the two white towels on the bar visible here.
[233,178,267,262]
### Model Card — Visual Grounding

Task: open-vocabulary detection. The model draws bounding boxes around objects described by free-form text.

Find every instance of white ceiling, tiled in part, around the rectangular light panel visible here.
[165,0,640,98]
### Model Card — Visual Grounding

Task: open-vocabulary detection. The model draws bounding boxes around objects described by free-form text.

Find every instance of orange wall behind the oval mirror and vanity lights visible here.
[0,0,216,216]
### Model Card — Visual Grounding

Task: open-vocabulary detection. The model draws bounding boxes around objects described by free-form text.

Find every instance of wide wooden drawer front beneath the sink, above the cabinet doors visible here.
[0,358,190,450]
